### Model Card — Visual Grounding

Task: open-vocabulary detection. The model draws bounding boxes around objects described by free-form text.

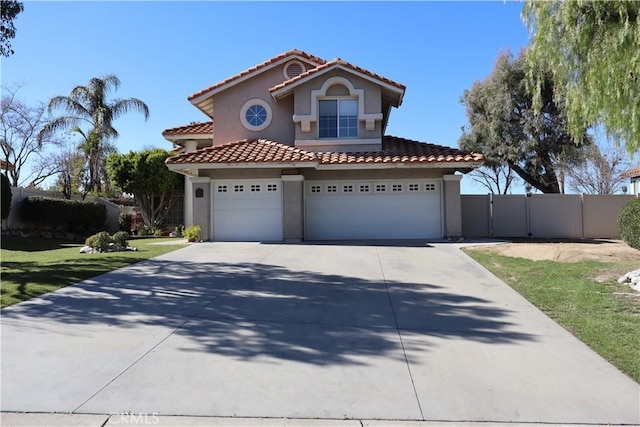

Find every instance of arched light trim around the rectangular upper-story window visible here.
[293,77,382,132]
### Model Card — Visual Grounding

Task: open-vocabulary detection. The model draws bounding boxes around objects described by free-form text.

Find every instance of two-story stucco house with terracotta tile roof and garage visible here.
[163,50,483,241]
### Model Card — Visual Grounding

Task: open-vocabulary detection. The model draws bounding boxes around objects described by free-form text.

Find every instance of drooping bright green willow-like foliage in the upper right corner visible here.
[522,0,640,153]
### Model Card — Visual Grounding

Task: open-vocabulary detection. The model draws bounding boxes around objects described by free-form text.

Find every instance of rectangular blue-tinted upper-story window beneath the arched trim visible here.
[318,99,358,138]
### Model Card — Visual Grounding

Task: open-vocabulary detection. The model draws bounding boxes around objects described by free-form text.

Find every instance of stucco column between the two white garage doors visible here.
[282,175,304,242]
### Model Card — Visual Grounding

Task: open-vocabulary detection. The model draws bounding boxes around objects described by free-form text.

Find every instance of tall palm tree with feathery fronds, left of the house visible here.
[45,74,149,196]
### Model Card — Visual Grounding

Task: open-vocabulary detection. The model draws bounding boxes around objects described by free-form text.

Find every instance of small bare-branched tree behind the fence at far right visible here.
[567,140,631,194]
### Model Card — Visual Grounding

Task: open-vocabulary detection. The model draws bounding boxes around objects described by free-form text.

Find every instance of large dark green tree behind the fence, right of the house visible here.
[458,52,590,193]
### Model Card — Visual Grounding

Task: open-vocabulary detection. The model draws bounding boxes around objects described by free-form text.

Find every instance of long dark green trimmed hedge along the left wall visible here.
[20,196,107,233]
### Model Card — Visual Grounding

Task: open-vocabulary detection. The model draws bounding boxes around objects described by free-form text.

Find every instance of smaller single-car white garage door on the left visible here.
[213,180,282,242]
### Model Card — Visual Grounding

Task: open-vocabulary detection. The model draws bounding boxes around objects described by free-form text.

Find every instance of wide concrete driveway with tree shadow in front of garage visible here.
[1,242,640,424]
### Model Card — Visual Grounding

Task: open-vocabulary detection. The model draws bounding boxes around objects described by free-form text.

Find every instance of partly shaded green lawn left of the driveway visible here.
[0,237,184,307]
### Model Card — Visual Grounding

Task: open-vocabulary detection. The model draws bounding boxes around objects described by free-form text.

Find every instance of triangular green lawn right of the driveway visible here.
[466,249,640,382]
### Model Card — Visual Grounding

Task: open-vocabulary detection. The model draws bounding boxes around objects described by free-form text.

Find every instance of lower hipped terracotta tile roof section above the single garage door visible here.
[167,139,317,165]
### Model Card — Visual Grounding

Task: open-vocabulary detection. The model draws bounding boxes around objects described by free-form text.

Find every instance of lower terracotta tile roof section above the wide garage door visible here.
[318,136,484,165]
